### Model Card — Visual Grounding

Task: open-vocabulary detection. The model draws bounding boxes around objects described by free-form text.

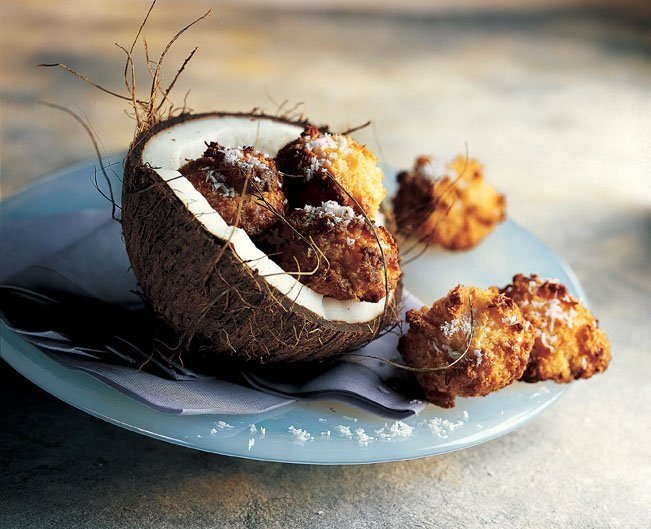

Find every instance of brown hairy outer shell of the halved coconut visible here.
[122,113,399,364]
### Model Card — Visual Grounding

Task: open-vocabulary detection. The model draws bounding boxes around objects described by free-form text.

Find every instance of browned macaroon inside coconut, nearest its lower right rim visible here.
[270,201,401,302]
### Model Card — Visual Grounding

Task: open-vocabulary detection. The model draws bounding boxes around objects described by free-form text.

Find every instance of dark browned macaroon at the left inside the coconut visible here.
[179,143,286,236]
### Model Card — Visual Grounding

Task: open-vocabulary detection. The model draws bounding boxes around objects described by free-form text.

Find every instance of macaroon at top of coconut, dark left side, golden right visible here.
[276,126,386,219]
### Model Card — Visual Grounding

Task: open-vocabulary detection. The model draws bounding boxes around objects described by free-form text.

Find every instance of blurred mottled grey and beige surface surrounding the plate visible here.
[0,0,651,528]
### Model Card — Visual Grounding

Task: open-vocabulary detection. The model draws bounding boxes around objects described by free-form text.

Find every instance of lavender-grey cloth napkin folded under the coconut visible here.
[0,210,424,419]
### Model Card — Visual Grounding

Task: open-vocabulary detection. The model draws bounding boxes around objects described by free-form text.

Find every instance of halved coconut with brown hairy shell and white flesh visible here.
[122,113,399,363]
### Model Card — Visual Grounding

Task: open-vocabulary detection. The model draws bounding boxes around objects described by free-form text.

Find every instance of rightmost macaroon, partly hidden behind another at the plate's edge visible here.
[502,274,610,383]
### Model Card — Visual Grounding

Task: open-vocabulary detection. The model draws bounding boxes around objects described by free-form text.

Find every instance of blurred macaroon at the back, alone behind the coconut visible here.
[393,156,506,250]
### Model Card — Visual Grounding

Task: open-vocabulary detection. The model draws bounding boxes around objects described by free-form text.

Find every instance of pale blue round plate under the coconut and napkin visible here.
[1,156,585,464]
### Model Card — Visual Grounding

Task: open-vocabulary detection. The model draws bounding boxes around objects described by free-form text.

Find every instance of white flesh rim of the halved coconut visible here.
[142,116,395,323]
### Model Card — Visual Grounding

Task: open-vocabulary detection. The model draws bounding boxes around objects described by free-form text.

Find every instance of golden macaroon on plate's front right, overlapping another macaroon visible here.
[398,285,534,408]
